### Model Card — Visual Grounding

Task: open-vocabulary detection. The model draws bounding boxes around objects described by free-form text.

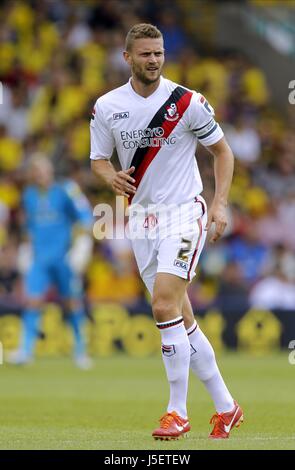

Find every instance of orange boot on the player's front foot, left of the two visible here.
[152,411,191,441]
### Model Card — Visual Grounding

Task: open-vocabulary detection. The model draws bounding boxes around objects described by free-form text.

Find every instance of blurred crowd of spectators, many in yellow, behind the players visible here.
[0,0,295,320]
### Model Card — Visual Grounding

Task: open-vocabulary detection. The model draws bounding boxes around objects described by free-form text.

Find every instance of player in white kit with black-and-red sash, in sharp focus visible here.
[90,23,243,440]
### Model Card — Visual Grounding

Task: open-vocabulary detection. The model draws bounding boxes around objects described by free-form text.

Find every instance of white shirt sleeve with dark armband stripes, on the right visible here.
[190,93,224,146]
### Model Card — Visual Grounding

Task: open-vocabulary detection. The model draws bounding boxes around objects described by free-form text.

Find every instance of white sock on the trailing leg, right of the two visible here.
[187,322,234,413]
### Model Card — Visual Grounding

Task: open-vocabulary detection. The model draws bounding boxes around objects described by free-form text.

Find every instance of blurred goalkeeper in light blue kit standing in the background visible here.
[9,154,92,369]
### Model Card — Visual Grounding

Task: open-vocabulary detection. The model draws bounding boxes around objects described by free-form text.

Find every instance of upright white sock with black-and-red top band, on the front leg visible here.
[157,317,190,418]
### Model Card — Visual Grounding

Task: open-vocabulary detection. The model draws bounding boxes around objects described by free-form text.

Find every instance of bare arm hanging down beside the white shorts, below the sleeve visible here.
[206,137,234,243]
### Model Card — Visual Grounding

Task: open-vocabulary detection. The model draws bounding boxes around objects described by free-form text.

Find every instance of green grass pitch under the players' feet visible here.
[0,351,295,452]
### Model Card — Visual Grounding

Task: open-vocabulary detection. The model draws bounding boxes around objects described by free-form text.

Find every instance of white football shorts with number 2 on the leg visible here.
[128,196,207,294]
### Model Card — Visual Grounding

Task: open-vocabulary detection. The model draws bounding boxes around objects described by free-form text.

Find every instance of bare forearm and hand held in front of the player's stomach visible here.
[91,159,136,197]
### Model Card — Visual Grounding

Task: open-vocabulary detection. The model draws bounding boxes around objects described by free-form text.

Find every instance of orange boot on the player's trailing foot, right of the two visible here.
[209,401,244,439]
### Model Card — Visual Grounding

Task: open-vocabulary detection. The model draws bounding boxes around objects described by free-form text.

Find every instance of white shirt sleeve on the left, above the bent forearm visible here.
[90,103,115,160]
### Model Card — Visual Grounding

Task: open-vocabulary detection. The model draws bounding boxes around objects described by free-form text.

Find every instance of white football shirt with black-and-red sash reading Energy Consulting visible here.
[90,77,223,207]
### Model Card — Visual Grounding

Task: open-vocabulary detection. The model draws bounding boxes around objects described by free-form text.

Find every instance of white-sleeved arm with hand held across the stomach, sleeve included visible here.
[90,100,136,197]
